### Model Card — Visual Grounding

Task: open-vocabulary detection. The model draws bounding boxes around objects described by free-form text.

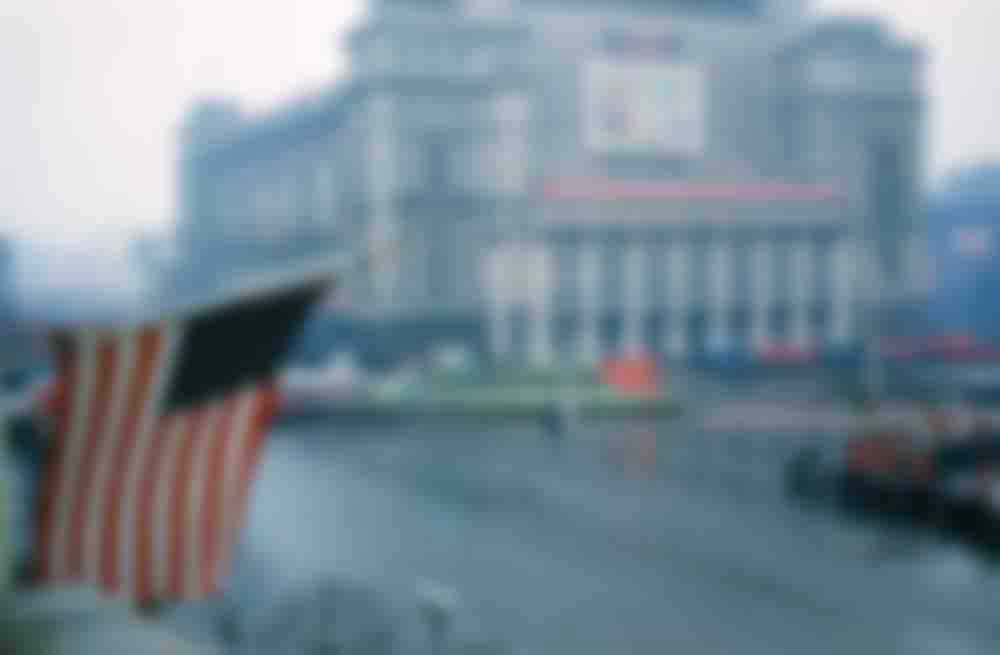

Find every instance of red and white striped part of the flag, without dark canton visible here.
[38,324,274,602]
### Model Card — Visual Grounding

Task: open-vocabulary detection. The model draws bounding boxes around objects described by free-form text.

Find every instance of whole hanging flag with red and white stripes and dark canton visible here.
[30,272,327,604]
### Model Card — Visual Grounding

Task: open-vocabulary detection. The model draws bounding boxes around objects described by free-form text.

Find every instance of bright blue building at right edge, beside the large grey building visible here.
[928,164,1000,341]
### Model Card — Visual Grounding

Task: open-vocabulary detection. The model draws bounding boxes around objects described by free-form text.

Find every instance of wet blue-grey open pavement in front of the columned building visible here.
[229,416,1000,655]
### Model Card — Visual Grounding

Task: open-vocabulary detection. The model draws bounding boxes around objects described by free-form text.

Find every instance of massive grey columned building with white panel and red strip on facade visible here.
[172,0,924,361]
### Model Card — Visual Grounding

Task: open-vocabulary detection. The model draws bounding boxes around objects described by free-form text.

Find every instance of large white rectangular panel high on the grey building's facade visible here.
[582,57,705,157]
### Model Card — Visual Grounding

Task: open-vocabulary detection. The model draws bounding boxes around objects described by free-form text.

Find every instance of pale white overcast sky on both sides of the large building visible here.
[0,0,1000,292]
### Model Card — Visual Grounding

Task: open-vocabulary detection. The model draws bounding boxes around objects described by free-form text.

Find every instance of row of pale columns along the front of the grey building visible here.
[489,239,856,364]
